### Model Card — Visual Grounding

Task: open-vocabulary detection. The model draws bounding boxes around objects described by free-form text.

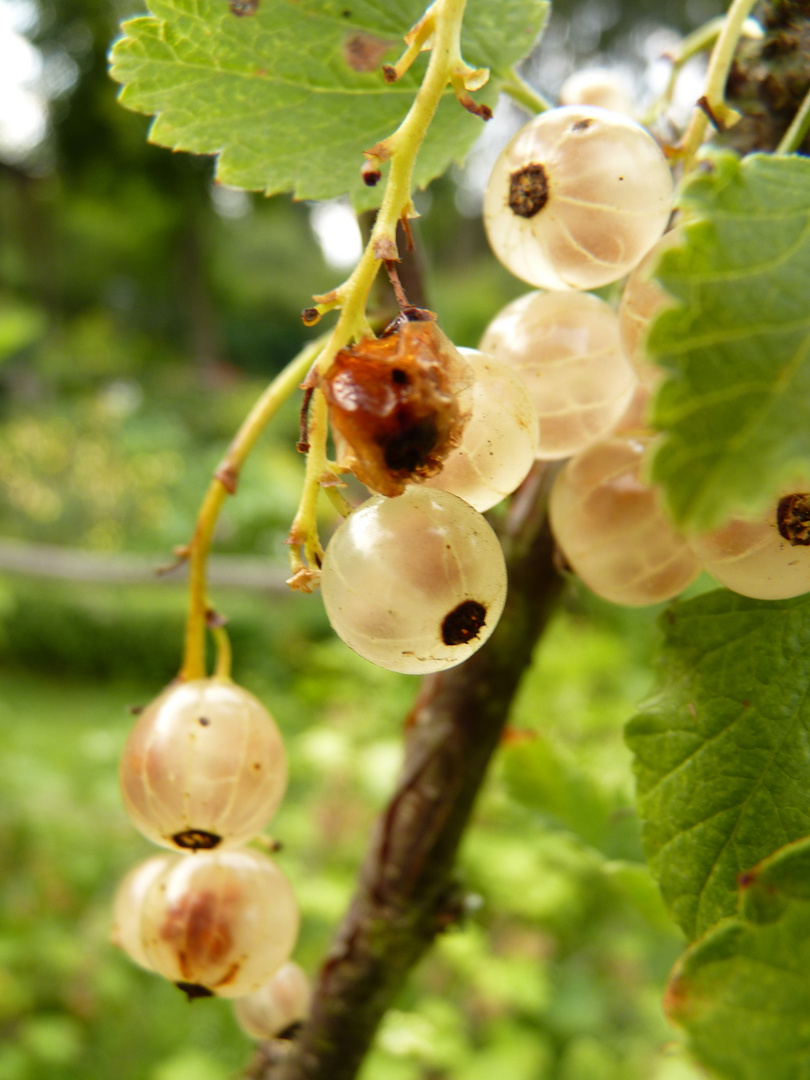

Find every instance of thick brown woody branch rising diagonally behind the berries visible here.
[251,469,561,1080]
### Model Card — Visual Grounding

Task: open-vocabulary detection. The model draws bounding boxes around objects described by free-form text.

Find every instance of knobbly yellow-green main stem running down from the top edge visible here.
[289,0,487,591]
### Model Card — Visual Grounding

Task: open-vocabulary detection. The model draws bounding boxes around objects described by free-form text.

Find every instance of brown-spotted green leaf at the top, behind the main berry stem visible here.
[111,0,548,208]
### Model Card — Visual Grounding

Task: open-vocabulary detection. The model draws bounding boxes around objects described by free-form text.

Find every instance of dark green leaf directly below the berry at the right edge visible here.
[627,590,810,937]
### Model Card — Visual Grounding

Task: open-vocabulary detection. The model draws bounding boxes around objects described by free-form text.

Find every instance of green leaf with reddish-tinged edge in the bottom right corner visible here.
[664,840,810,1080]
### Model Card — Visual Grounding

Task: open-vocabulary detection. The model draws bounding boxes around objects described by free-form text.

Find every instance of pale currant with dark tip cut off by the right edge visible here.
[691,486,810,600]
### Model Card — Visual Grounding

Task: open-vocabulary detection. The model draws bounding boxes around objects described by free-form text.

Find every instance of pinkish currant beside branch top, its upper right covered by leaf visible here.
[549,436,700,606]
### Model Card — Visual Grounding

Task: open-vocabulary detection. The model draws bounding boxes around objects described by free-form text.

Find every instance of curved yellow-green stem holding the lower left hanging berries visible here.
[179,338,323,679]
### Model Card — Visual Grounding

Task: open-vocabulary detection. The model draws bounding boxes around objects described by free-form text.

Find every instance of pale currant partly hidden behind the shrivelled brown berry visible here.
[424,349,539,512]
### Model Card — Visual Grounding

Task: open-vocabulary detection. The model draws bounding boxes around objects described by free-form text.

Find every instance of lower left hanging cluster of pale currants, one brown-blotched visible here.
[112,677,306,1034]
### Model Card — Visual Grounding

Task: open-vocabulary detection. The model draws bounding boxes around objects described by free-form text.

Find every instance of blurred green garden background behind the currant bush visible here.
[0,0,723,1080]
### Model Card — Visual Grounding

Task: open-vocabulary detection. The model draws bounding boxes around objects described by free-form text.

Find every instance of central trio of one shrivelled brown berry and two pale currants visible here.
[321,312,539,674]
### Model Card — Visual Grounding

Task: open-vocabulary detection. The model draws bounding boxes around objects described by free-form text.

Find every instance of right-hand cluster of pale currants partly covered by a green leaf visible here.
[481,102,810,605]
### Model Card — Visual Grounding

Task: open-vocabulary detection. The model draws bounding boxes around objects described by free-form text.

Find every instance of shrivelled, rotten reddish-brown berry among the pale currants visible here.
[320,308,473,496]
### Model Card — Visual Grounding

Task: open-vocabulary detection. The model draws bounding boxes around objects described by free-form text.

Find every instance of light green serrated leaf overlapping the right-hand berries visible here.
[649,151,810,530]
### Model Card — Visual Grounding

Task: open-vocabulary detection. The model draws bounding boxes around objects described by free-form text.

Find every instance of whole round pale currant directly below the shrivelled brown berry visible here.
[321,486,507,675]
